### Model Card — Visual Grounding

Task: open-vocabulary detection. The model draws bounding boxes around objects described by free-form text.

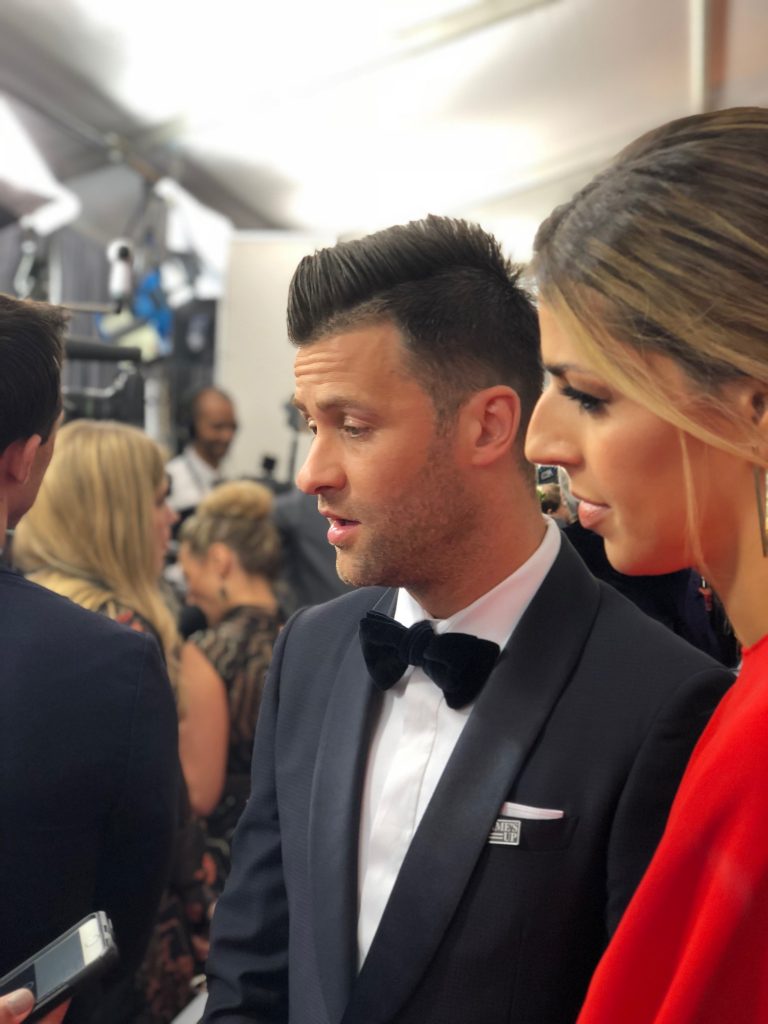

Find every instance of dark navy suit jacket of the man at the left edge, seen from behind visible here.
[0,571,178,974]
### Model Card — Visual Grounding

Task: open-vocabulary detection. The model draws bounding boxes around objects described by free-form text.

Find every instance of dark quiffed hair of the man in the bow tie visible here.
[288,216,542,436]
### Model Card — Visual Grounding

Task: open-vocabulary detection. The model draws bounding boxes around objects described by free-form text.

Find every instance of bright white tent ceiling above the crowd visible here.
[0,0,768,257]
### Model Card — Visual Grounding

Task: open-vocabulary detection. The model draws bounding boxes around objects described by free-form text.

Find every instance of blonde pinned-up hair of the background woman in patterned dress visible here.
[179,480,281,580]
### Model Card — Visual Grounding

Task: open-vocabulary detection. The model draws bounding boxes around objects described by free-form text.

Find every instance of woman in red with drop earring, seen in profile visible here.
[526,108,768,1024]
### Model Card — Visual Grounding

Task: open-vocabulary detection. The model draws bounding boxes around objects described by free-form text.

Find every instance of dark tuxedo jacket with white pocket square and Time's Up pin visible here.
[202,542,732,1024]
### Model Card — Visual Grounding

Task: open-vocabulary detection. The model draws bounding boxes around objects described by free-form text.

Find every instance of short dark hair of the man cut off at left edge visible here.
[0,294,69,453]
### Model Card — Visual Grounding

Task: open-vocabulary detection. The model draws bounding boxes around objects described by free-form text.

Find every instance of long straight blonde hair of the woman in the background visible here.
[13,420,178,675]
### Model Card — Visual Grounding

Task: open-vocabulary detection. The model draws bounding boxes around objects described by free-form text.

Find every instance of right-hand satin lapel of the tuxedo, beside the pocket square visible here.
[344,539,600,1024]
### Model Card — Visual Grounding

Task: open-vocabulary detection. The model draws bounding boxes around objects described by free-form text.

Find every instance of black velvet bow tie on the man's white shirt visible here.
[359,611,499,708]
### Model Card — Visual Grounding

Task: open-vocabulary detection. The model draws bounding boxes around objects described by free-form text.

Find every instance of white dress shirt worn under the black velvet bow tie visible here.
[357,516,560,966]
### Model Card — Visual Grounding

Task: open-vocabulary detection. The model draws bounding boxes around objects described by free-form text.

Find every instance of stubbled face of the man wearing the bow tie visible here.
[295,324,473,605]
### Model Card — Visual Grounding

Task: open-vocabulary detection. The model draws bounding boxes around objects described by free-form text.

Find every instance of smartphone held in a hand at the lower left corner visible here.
[0,910,118,1021]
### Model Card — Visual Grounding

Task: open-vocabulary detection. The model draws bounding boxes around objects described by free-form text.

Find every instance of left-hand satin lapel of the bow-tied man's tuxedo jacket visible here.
[308,590,396,1024]
